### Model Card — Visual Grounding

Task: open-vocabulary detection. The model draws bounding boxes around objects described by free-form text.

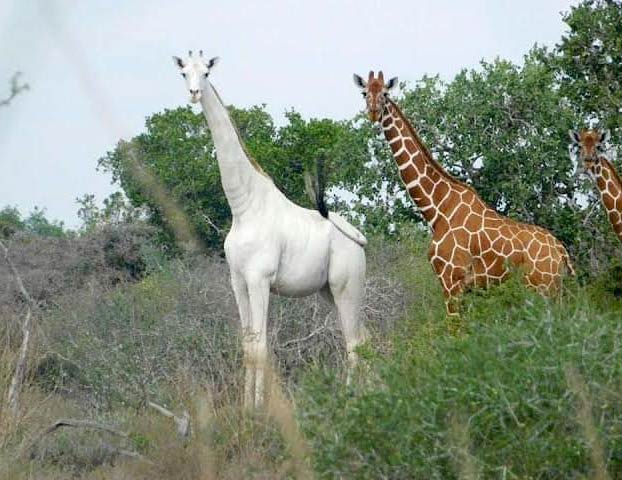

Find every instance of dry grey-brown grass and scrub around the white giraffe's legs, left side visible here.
[0,234,406,479]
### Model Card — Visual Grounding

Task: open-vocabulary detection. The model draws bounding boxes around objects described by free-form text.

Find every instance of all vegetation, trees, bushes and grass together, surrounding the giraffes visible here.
[0,0,622,479]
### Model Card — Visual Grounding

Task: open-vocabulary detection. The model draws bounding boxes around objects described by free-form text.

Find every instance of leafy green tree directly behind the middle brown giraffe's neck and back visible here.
[344,49,581,248]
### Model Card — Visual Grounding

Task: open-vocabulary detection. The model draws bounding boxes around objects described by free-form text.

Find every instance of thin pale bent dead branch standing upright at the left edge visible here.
[0,241,34,418]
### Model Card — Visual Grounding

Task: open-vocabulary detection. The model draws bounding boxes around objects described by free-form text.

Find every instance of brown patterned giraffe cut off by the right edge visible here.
[569,130,622,240]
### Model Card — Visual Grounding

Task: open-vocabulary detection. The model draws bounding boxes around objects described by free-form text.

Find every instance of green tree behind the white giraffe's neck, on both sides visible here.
[98,105,360,249]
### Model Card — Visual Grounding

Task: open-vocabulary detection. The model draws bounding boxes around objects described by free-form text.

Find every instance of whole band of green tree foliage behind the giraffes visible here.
[92,0,622,273]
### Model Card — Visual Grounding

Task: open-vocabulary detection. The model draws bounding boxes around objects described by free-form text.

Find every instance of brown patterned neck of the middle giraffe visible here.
[381,100,478,230]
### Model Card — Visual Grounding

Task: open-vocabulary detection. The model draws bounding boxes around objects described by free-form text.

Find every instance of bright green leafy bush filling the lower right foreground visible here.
[298,274,622,479]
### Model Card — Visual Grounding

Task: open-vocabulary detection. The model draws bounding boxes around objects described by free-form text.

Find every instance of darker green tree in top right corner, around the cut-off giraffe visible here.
[545,0,622,271]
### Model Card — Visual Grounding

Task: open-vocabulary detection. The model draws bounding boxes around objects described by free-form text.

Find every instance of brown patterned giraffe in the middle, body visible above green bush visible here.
[354,72,574,315]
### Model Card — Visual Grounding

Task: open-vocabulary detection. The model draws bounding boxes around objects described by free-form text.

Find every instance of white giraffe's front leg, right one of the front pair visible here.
[243,278,270,408]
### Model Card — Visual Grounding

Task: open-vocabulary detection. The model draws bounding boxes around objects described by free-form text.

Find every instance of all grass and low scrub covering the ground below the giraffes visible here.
[0,232,622,479]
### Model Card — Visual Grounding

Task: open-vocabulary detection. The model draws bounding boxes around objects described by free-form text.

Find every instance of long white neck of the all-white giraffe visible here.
[201,82,270,217]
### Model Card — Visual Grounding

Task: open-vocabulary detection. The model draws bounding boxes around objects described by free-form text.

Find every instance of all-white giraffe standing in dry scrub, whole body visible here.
[173,52,367,407]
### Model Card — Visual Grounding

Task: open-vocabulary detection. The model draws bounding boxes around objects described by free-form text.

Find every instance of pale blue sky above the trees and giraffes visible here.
[0,0,575,227]
